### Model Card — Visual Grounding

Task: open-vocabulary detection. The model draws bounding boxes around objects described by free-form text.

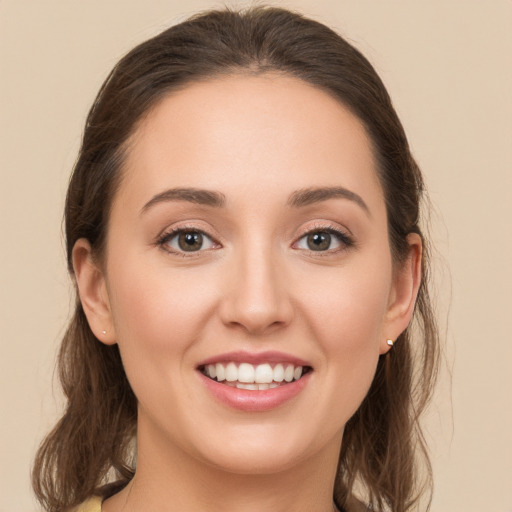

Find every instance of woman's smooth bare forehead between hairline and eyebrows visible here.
[119,73,382,213]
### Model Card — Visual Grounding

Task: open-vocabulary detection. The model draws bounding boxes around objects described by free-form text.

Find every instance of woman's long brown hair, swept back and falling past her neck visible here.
[33,7,438,512]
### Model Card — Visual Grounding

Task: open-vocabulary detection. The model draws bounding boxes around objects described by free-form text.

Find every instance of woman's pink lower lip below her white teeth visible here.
[198,372,312,412]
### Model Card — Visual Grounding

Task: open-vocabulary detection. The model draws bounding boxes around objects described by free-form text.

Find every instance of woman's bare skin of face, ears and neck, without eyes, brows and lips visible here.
[73,74,421,512]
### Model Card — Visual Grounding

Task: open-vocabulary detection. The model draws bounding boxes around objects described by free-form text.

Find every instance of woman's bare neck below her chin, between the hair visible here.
[103,416,341,512]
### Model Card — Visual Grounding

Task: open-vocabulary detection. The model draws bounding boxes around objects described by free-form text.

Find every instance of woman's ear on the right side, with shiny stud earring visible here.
[380,233,423,354]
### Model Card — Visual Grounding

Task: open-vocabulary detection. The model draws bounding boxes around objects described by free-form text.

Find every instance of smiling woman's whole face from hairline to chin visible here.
[76,75,420,473]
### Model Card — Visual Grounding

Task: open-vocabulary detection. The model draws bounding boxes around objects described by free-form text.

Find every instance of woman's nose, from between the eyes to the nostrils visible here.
[220,247,294,335]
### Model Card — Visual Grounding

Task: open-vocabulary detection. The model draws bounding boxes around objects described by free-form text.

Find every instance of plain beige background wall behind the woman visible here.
[0,0,512,512]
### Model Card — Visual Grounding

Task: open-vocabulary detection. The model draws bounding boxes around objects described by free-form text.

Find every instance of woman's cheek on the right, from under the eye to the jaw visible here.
[303,256,391,408]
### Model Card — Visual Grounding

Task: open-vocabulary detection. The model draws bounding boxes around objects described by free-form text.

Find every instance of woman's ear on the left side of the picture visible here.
[72,238,116,345]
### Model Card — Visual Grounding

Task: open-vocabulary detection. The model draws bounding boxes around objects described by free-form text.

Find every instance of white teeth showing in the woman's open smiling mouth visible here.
[198,361,313,391]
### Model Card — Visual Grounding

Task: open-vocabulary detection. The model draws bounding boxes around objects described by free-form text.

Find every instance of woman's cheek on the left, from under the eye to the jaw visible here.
[104,258,220,412]
